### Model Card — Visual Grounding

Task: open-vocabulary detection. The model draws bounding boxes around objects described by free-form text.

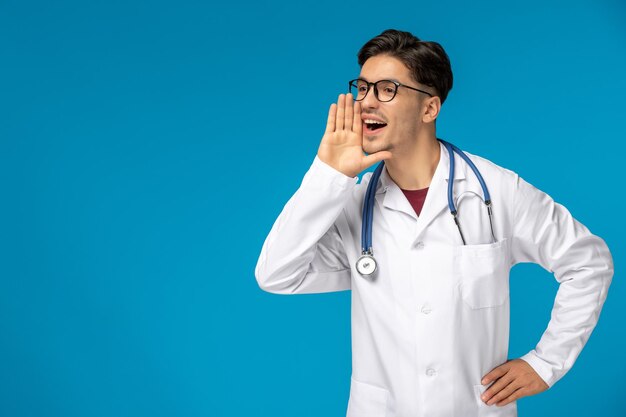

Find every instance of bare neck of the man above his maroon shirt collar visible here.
[385,132,441,190]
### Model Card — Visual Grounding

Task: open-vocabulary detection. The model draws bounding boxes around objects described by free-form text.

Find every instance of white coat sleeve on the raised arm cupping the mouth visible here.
[255,156,358,294]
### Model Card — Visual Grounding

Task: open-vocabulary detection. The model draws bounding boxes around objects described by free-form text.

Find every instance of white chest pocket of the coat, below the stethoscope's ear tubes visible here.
[457,239,510,309]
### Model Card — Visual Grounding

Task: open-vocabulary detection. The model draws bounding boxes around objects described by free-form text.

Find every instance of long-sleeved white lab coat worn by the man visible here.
[255,144,613,417]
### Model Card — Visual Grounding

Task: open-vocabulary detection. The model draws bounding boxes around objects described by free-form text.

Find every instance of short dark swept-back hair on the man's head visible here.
[357,29,452,104]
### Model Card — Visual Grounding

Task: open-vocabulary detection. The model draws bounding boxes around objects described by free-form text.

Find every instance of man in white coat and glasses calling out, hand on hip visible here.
[255,30,613,417]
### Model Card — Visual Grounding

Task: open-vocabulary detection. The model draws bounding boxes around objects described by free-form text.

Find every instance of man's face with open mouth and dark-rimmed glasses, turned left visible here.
[359,55,430,154]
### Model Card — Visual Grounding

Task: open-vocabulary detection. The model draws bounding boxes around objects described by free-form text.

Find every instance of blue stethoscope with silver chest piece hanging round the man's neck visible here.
[356,138,496,275]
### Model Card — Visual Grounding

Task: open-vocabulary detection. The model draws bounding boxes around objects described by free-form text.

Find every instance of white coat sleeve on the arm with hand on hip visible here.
[512,176,613,387]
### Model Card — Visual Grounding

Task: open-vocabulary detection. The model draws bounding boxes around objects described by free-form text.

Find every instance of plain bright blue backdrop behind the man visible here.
[0,0,626,417]
